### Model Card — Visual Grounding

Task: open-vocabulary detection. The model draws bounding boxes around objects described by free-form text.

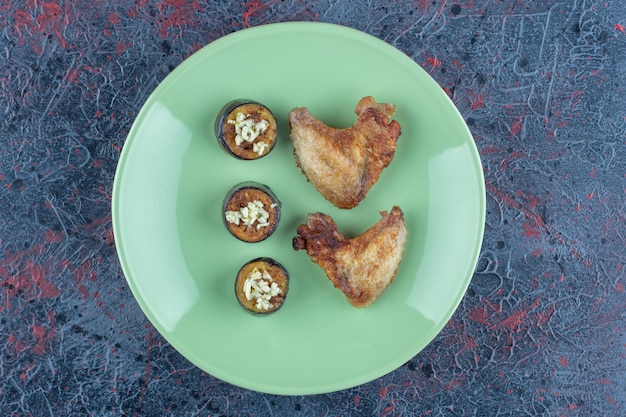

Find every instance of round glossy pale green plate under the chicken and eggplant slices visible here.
[113,23,485,395]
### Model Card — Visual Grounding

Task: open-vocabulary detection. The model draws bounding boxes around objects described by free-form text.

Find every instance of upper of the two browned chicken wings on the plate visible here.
[289,96,401,209]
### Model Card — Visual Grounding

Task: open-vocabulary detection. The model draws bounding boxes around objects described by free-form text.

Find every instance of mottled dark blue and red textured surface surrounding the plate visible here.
[0,0,626,417]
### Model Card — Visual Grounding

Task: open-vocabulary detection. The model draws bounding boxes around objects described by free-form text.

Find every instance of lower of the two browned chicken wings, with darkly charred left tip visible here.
[293,206,407,308]
